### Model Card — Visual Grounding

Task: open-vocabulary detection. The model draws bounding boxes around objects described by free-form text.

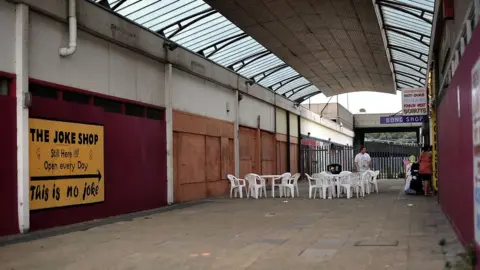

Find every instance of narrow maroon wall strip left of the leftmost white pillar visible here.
[0,90,18,236]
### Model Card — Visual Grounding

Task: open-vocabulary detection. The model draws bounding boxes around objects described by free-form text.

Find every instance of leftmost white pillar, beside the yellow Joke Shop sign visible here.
[15,4,30,233]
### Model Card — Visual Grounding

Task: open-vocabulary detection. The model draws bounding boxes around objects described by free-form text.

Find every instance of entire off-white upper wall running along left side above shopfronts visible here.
[0,0,353,144]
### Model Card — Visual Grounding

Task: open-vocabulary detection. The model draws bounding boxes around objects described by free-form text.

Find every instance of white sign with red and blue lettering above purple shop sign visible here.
[402,88,428,115]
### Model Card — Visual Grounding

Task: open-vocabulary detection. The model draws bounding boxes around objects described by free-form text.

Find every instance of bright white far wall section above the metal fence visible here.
[300,118,353,145]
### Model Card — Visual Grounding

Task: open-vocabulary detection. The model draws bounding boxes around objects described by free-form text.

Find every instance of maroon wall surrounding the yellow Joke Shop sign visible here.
[30,97,167,230]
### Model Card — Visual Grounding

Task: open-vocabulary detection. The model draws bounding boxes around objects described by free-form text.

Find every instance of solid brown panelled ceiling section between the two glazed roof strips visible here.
[205,0,395,96]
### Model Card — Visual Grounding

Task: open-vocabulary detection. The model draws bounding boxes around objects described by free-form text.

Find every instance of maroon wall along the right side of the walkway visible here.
[438,24,480,244]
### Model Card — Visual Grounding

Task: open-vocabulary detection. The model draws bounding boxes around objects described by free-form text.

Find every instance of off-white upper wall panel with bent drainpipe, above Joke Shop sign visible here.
[29,12,165,106]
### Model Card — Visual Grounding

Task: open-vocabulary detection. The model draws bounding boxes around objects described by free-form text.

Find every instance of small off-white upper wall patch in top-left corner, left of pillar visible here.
[0,1,15,73]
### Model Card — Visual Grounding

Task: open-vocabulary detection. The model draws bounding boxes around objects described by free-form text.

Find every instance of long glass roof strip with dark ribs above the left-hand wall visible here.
[90,0,319,100]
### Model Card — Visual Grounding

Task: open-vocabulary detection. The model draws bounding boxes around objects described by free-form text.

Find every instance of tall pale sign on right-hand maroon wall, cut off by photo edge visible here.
[472,60,480,244]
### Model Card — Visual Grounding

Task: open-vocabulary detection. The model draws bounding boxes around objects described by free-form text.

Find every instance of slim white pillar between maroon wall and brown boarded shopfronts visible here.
[165,63,175,204]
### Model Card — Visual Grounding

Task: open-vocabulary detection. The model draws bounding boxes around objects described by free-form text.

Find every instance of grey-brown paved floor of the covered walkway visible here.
[0,180,461,270]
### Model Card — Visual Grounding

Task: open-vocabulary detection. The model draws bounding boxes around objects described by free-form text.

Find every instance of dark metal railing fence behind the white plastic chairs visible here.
[300,142,420,179]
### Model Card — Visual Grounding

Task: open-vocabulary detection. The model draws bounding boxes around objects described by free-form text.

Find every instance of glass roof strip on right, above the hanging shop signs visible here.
[376,0,435,88]
